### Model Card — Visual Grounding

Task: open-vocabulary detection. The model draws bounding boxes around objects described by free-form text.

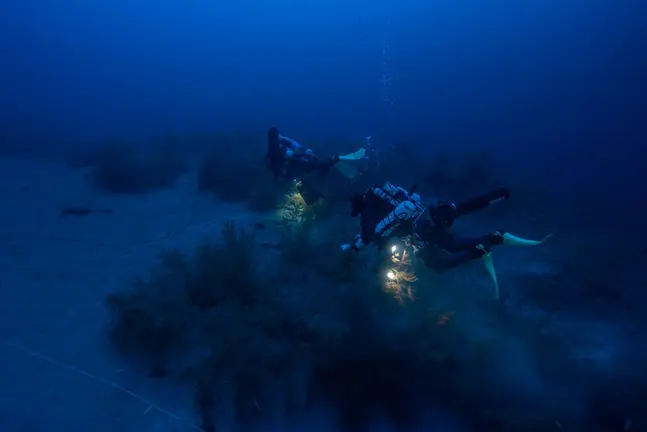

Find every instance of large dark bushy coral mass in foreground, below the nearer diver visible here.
[106,218,576,431]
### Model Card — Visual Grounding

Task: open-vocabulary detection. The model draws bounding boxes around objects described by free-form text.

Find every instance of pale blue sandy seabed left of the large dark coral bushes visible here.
[0,158,268,432]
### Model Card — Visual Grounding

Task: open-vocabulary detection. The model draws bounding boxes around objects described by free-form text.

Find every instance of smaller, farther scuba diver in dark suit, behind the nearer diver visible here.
[265,127,339,179]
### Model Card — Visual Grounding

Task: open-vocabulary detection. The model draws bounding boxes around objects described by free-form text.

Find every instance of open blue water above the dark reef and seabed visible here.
[0,0,646,142]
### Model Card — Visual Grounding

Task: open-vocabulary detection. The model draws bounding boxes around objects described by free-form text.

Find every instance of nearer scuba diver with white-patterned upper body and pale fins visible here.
[342,182,550,299]
